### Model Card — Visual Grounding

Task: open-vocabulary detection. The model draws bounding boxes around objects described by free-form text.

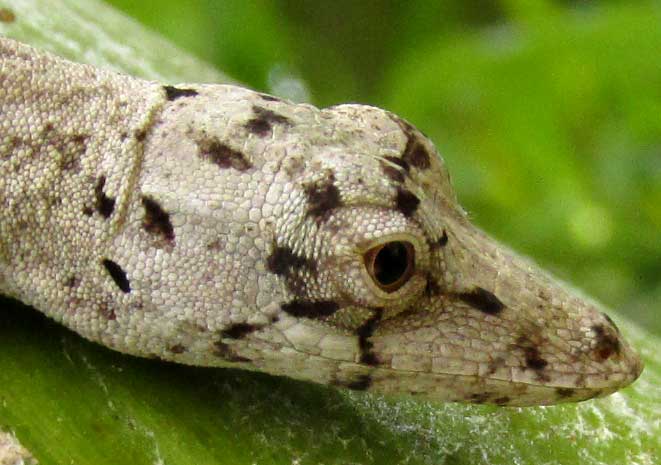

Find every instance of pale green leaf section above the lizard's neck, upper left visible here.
[0,0,232,83]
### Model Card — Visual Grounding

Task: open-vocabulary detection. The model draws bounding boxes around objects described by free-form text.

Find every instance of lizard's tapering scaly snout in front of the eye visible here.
[354,216,643,405]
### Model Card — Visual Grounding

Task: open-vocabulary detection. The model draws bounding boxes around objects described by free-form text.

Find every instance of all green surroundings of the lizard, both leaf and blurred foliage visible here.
[0,0,661,465]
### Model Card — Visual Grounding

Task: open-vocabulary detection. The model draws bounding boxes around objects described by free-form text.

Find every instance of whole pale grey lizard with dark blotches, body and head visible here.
[0,39,642,405]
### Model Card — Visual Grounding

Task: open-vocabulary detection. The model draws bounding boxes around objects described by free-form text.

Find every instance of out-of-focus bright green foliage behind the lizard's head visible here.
[109,0,661,334]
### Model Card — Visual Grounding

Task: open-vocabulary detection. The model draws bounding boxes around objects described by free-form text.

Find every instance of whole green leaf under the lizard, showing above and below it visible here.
[0,0,661,465]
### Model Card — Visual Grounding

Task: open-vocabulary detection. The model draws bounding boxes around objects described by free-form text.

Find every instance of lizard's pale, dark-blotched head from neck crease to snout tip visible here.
[142,86,642,405]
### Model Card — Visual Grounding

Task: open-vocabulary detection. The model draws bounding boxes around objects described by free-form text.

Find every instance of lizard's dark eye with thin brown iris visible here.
[363,241,415,293]
